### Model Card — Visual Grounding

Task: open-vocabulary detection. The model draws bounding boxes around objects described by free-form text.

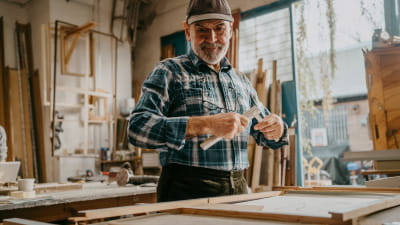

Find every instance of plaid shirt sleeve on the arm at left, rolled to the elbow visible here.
[128,63,188,150]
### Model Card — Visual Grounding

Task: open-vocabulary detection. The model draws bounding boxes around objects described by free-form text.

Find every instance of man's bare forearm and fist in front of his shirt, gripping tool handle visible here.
[186,112,249,139]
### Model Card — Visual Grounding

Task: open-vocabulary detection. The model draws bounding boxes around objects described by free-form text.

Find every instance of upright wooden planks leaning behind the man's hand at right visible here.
[248,59,295,192]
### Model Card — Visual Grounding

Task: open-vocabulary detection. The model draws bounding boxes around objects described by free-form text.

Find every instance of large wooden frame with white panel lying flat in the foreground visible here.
[66,187,400,225]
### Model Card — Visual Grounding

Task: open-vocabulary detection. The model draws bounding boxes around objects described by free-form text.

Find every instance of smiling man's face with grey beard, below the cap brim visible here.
[185,20,232,65]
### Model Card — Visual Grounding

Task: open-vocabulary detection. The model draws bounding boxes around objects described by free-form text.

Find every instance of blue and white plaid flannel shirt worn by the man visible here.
[128,51,287,171]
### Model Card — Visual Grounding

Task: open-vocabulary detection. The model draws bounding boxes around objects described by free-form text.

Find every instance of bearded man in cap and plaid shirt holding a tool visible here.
[129,0,287,202]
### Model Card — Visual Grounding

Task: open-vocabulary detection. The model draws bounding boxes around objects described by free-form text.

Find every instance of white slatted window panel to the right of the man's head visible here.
[239,9,292,81]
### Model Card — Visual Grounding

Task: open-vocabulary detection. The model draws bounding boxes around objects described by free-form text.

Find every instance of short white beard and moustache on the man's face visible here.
[190,42,229,65]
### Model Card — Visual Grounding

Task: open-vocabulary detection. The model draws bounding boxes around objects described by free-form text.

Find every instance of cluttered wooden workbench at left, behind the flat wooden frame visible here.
[0,183,156,222]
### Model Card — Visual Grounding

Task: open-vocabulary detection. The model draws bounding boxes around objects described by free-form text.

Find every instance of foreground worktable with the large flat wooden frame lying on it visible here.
[69,186,400,225]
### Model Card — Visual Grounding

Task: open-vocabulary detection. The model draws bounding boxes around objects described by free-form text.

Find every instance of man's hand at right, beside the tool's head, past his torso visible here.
[254,114,285,140]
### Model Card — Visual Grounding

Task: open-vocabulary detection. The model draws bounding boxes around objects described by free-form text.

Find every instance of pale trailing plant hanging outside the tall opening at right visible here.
[295,0,336,155]
